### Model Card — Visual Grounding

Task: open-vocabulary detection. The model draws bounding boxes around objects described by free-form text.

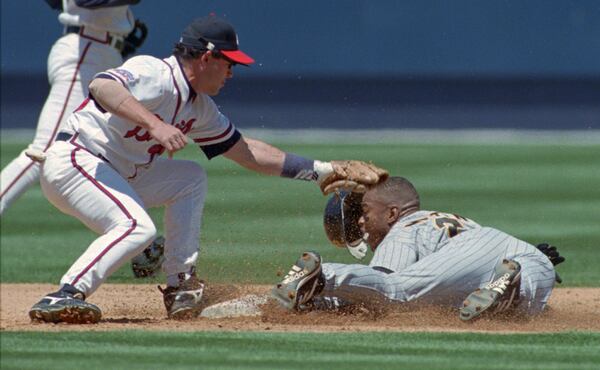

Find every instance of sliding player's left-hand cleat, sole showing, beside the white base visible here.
[271,251,325,310]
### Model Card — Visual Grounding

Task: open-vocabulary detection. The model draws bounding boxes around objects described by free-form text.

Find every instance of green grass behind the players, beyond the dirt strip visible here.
[0,134,600,287]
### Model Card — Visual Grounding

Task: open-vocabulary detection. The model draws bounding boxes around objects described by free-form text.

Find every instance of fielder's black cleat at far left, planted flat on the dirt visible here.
[29,284,102,324]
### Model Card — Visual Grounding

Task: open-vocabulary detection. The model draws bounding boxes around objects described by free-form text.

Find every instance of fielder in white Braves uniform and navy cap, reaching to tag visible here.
[29,16,387,323]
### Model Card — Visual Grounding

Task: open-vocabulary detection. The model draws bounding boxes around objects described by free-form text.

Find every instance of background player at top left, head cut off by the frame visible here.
[0,0,139,214]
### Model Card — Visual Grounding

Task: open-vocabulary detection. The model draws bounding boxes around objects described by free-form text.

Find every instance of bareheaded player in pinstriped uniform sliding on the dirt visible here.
[273,177,564,321]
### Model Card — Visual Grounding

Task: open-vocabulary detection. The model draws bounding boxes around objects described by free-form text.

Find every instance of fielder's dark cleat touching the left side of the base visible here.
[158,273,204,320]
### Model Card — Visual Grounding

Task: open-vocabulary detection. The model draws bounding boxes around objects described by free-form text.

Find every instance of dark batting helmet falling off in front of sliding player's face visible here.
[323,191,363,248]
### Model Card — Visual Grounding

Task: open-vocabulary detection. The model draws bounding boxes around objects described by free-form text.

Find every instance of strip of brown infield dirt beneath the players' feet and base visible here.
[0,284,600,333]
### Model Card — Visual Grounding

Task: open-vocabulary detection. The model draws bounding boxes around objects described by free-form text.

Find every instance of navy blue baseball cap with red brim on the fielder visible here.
[179,15,254,65]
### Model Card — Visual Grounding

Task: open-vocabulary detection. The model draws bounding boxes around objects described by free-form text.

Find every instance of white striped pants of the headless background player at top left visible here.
[0,34,122,214]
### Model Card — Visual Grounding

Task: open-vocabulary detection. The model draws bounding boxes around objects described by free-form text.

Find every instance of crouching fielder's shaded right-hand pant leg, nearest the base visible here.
[131,158,207,285]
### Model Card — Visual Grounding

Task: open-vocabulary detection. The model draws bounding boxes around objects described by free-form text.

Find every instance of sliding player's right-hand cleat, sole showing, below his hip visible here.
[459,259,521,321]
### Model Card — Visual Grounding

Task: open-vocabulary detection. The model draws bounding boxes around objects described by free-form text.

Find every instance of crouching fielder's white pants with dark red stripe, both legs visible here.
[41,139,207,296]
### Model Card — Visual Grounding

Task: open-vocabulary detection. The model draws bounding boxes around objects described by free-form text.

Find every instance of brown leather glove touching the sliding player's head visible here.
[319,161,389,195]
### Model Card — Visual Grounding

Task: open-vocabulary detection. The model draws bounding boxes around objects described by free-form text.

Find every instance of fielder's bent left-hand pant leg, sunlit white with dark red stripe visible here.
[41,142,156,296]
